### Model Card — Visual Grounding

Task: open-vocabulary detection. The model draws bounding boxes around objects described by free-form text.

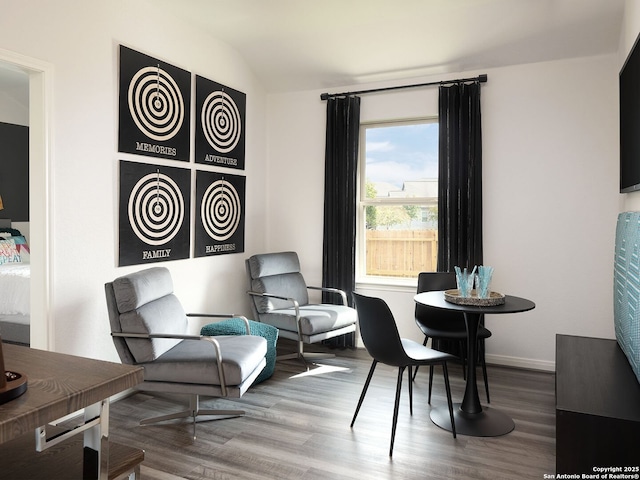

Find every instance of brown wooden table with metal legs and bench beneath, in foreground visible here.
[0,344,144,480]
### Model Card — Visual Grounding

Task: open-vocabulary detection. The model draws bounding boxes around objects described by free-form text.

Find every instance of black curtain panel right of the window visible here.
[438,82,482,272]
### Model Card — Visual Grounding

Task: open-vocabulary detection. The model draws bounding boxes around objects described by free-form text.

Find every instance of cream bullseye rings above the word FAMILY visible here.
[128,172,185,245]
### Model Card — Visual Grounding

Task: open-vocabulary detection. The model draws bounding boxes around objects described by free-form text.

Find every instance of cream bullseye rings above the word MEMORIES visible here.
[127,66,184,141]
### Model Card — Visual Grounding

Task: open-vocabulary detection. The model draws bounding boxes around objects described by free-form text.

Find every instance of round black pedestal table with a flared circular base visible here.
[414,291,536,437]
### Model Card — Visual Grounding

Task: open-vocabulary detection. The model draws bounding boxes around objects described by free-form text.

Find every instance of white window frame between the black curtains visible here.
[355,115,439,291]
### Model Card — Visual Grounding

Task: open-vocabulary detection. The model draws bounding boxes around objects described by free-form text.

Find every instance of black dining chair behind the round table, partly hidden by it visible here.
[413,272,491,403]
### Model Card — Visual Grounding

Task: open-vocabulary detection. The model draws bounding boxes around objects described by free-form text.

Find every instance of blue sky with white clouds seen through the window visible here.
[366,122,438,190]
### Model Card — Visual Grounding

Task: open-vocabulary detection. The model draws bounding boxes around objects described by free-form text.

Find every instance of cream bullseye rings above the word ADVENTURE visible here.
[200,91,242,153]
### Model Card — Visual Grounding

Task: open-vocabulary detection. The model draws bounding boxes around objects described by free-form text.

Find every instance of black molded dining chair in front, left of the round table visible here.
[351,293,456,457]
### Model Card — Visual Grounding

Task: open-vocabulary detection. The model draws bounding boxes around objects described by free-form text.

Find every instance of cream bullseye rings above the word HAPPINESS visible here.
[200,180,242,242]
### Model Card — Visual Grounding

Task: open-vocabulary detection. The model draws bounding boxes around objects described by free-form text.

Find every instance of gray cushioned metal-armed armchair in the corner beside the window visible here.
[246,252,358,364]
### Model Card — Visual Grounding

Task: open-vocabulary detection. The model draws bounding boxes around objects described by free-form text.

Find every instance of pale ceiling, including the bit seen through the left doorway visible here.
[0,0,625,101]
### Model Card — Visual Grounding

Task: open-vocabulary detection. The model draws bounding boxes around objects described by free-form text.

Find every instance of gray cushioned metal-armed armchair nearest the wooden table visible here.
[105,267,267,438]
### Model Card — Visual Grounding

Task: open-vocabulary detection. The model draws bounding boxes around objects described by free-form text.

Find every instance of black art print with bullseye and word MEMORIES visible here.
[118,45,191,161]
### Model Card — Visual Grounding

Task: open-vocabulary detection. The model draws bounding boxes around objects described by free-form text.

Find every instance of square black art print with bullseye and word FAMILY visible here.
[118,160,191,266]
